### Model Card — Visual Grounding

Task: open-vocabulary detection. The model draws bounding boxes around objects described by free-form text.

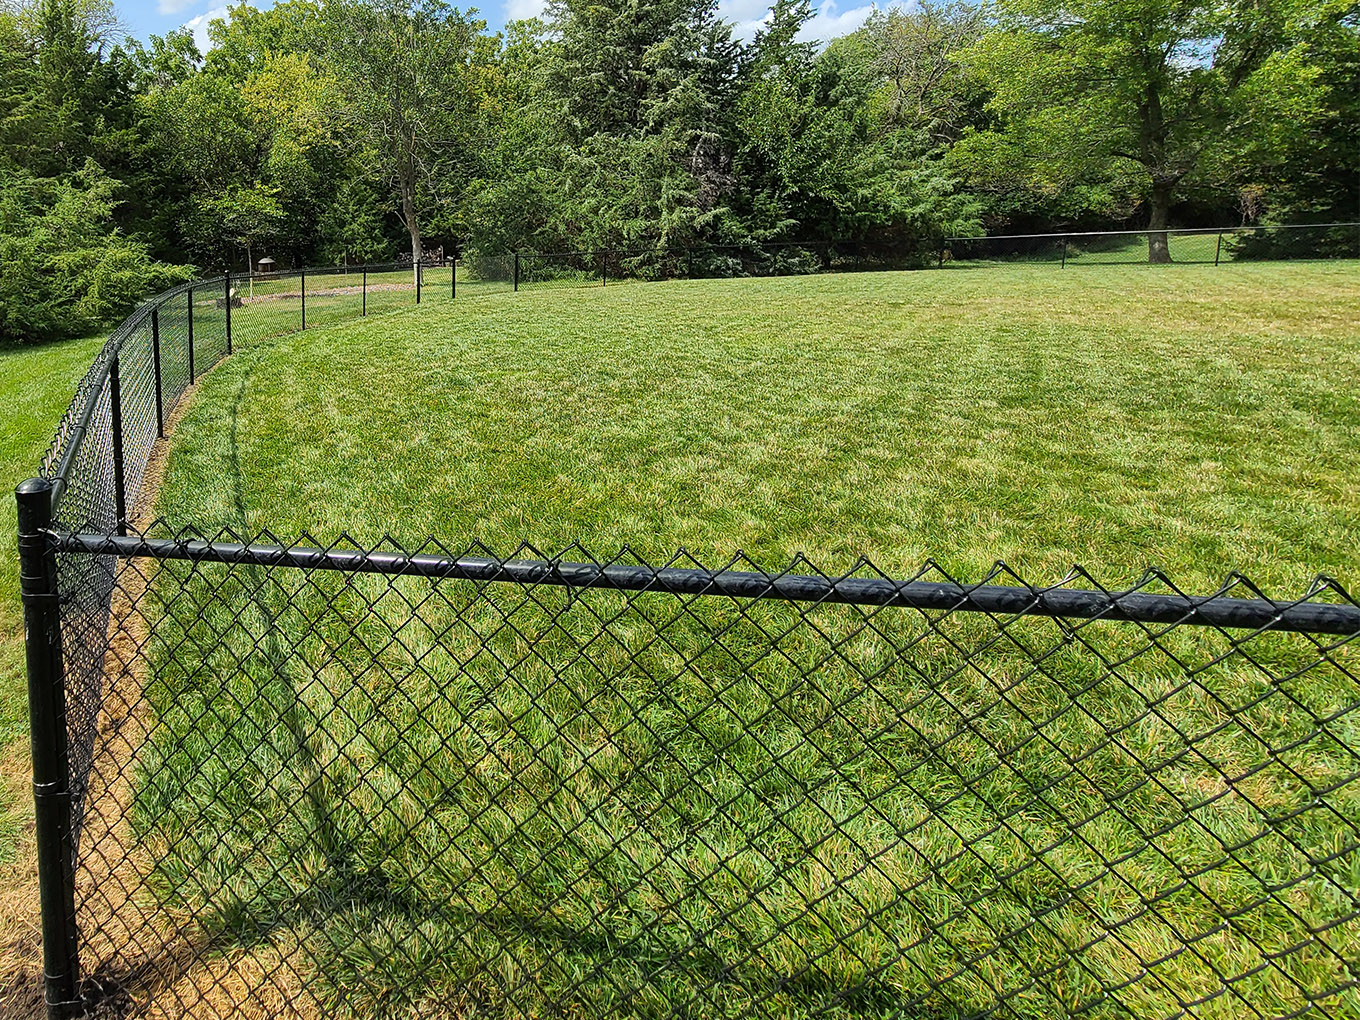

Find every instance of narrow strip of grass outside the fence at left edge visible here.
[0,339,103,868]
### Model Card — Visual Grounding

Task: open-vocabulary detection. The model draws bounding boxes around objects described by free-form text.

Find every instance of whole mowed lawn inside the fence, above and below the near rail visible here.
[103,265,1360,1017]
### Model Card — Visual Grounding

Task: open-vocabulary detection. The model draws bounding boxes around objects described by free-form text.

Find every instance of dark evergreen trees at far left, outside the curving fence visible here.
[0,0,185,343]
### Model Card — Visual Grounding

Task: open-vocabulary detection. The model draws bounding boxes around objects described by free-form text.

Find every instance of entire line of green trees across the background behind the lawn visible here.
[0,0,1360,341]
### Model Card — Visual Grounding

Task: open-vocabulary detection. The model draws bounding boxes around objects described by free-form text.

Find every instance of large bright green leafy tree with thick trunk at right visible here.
[953,0,1344,248]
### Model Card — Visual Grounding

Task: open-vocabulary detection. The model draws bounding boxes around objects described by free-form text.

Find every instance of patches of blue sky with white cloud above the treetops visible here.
[116,0,873,54]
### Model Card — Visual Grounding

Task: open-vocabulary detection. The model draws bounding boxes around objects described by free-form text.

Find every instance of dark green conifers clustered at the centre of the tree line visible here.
[468,0,976,259]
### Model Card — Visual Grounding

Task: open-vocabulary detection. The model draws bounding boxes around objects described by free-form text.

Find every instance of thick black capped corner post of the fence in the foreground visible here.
[15,479,82,1020]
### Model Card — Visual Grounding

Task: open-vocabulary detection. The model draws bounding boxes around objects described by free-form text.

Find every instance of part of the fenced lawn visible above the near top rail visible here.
[160,264,1360,593]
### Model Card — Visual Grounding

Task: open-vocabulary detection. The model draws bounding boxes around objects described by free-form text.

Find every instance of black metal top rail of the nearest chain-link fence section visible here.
[56,533,1360,636]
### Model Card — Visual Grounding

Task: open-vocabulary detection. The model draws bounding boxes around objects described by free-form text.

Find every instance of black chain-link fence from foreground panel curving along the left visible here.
[19,227,1360,1017]
